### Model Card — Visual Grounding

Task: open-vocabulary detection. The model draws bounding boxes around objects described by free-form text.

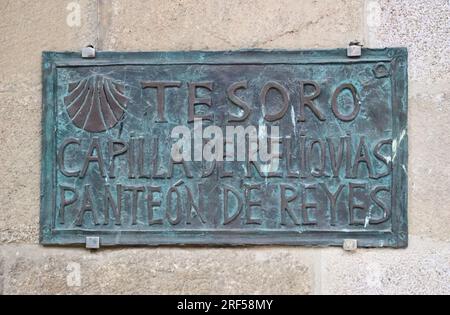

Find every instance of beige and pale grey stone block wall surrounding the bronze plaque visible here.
[0,0,450,294]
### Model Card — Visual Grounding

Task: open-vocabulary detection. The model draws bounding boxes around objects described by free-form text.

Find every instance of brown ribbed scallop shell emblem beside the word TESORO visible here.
[64,75,128,133]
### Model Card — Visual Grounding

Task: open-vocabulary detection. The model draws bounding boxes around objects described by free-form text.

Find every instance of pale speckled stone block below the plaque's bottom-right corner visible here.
[321,238,450,295]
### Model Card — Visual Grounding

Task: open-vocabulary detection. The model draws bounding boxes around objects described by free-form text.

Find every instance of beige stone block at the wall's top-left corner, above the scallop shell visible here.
[0,0,97,93]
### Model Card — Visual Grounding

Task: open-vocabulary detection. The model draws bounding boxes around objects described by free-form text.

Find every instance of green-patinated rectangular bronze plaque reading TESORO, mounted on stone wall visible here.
[41,48,408,247]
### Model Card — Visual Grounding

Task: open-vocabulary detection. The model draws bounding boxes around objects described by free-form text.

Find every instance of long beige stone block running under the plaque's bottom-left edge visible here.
[0,245,315,294]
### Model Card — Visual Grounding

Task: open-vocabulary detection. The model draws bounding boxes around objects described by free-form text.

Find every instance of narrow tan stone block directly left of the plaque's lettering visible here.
[0,92,41,243]
